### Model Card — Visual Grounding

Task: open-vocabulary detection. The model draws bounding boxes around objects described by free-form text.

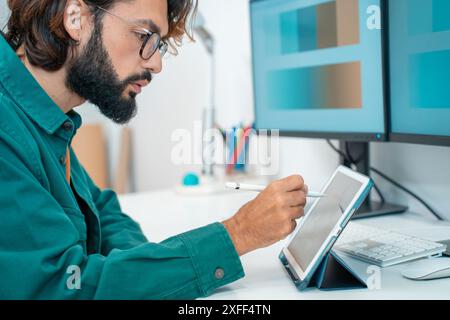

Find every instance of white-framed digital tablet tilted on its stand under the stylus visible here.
[280,166,373,289]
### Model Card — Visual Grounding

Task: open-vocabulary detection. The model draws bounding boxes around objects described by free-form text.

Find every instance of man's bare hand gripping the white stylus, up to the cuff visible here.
[223,175,308,256]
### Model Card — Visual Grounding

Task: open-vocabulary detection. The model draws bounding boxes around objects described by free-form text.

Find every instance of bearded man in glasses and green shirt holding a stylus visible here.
[0,0,307,299]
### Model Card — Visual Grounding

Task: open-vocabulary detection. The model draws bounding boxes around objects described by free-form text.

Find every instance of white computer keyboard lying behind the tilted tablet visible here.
[334,222,446,267]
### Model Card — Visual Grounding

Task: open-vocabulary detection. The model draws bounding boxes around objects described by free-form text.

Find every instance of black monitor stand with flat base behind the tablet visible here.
[339,141,408,219]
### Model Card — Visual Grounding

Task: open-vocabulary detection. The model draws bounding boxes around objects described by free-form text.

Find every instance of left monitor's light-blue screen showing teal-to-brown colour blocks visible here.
[251,0,385,139]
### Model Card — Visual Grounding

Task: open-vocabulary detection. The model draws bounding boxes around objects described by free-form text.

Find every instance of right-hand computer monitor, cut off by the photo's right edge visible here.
[388,0,450,146]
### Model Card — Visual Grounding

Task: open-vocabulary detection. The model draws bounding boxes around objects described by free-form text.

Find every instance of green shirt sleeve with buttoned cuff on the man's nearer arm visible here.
[0,133,244,299]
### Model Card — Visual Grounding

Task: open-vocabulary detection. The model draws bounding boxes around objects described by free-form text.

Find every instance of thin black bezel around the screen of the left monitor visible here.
[249,0,389,142]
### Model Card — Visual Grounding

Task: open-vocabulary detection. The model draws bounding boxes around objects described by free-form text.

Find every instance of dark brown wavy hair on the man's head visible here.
[4,0,198,71]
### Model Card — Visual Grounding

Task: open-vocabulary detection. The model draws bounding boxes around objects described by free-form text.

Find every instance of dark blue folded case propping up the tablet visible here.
[280,250,367,290]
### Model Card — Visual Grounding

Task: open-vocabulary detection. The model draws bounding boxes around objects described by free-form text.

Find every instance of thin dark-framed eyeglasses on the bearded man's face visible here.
[96,6,169,60]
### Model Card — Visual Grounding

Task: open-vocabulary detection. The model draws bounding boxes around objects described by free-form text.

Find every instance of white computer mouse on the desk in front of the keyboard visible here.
[402,258,450,280]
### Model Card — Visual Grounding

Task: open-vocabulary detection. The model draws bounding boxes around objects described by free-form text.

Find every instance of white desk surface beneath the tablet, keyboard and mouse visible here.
[121,190,450,299]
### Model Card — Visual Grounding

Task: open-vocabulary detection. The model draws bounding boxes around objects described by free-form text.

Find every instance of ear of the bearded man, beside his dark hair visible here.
[64,0,88,43]
